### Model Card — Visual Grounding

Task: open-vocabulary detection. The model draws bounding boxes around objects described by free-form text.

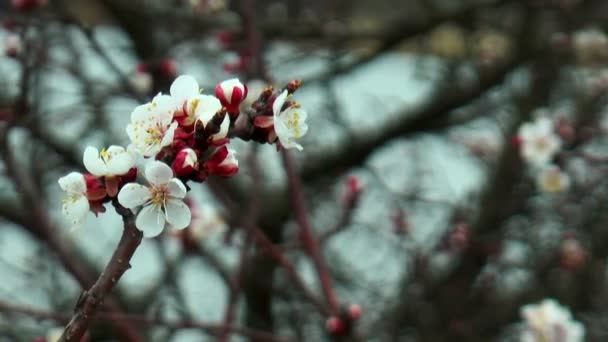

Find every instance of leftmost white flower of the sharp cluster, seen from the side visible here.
[59,172,90,227]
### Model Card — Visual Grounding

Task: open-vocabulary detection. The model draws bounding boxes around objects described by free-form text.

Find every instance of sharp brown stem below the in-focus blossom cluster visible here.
[59,214,142,342]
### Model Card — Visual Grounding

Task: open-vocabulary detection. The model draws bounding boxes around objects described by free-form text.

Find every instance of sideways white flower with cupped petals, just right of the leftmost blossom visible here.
[82,145,135,177]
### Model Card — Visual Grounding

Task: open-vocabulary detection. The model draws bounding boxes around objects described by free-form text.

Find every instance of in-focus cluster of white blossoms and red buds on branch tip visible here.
[59,75,308,237]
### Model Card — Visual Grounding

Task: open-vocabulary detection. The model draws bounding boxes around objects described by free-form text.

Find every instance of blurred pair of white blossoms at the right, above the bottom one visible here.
[517,116,570,193]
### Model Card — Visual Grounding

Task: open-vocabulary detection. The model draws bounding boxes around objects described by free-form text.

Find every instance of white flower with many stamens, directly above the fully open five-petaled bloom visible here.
[127,94,177,157]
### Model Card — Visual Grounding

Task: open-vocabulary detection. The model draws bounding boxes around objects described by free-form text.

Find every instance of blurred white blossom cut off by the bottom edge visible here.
[520,299,585,342]
